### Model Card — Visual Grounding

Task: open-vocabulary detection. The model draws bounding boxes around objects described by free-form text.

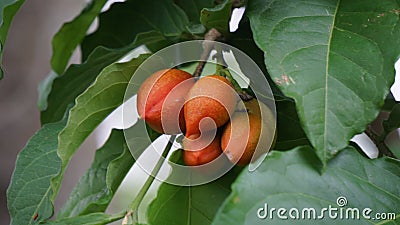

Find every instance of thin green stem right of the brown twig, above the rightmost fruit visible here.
[215,48,253,101]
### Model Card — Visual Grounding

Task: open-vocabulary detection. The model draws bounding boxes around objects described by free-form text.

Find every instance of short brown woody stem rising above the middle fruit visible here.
[193,28,222,77]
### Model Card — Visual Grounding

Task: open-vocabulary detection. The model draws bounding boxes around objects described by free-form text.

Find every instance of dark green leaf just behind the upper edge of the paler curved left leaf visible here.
[41,31,164,124]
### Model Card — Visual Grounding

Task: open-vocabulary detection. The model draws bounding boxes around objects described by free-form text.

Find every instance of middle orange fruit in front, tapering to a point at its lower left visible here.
[184,75,238,136]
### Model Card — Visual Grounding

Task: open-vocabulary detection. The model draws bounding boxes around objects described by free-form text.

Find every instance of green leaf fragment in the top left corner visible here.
[0,0,25,80]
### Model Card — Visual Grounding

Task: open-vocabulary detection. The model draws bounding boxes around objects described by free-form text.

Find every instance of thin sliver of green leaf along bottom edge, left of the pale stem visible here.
[43,213,125,225]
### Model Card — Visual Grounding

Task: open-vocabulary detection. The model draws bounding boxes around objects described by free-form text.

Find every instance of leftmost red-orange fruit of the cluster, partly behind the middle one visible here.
[137,69,195,134]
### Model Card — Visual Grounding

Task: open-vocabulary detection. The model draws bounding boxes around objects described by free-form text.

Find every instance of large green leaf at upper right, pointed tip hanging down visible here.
[248,0,400,164]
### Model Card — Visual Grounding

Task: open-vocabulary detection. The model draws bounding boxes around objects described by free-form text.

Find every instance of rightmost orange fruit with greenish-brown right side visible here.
[221,99,275,166]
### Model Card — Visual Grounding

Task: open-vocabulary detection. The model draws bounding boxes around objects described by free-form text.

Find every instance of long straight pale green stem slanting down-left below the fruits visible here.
[126,135,176,222]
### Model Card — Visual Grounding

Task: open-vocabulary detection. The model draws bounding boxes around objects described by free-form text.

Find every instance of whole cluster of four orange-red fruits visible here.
[137,69,272,166]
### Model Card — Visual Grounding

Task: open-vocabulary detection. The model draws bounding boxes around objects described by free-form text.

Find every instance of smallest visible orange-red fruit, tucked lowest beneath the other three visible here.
[182,132,222,166]
